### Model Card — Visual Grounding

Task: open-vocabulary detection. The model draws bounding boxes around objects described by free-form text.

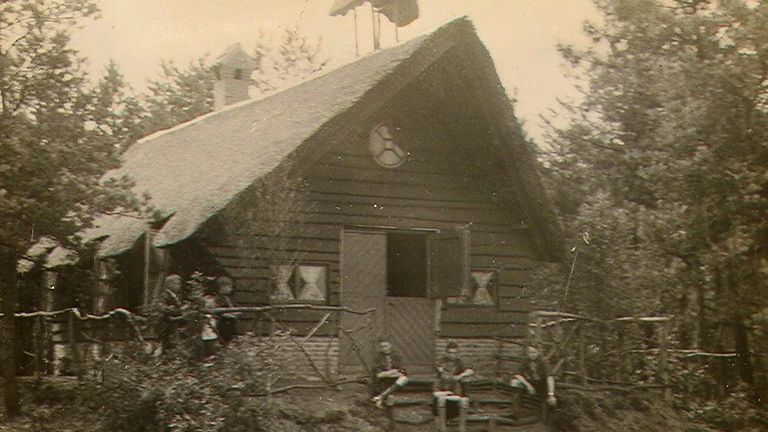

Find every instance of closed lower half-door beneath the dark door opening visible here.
[386,297,435,373]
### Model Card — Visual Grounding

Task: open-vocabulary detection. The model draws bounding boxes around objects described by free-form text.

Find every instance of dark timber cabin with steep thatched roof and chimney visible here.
[42,18,563,373]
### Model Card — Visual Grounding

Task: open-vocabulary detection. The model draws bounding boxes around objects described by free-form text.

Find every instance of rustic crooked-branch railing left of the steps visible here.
[0,304,375,393]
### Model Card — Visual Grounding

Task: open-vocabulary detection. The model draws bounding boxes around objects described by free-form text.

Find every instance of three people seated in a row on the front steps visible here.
[372,338,557,430]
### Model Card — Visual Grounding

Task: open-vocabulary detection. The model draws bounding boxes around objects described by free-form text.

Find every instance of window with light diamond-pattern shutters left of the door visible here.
[270,263,328,303]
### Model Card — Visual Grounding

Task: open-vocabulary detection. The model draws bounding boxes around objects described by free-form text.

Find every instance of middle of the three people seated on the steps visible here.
[432,341,475,431]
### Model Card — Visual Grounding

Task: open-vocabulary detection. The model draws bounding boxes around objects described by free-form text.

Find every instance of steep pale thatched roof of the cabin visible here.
[89,18,557,257]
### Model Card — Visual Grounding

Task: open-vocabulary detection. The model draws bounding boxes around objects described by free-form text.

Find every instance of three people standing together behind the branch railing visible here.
[157,271,237,359]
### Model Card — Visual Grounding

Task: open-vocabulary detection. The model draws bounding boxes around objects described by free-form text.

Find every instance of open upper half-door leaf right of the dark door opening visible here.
[429,230,469,298]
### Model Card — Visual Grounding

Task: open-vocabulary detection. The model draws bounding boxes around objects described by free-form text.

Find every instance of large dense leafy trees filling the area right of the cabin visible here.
[548,0,768,404]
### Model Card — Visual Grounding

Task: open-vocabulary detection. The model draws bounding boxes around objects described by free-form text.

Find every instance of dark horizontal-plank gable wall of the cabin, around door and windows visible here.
[201,52,539,337]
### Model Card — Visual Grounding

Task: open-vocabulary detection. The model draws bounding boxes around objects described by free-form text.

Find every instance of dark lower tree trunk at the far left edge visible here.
[0,253,21,418]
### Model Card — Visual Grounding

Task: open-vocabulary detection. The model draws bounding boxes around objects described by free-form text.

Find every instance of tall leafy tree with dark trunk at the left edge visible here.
[0,0,140,416]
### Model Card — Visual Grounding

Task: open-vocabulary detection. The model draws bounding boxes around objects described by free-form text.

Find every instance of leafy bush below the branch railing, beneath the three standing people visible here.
[91,334,292,432]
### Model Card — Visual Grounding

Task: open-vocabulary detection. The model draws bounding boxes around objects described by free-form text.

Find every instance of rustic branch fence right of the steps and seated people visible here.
[488,311,760,398]
